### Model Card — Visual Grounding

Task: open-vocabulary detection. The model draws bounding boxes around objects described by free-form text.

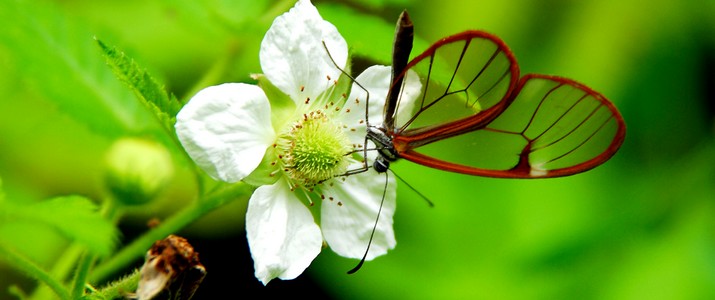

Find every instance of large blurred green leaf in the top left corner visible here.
[0,0,156,137]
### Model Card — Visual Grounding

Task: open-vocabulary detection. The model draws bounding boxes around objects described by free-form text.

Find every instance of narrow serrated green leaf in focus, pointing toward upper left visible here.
[95,38,181,133]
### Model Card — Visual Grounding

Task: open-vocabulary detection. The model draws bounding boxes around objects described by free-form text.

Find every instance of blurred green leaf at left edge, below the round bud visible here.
[0,196,118,256]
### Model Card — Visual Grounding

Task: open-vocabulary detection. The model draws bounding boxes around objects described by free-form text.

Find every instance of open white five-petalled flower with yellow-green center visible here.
[176,0,419,284]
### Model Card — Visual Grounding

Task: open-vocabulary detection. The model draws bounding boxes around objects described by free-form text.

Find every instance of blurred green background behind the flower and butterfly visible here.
[0,0,715,299]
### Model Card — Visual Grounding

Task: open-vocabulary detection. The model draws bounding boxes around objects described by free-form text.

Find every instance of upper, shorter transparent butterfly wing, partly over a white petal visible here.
[392,31,519,135]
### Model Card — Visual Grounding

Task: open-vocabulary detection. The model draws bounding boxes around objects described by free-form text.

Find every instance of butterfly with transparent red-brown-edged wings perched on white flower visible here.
[366,11,626,178]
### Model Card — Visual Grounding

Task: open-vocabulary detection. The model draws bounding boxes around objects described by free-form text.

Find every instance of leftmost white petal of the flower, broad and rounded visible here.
[175,83,275,182]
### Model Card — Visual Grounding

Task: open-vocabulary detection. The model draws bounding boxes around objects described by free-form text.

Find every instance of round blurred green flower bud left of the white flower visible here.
[104,138,174,205]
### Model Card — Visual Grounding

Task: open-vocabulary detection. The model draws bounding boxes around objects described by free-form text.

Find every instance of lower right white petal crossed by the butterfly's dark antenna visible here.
[321,170,397,260]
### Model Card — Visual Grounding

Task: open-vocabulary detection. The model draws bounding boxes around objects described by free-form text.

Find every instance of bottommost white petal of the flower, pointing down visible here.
[246,180,323,285]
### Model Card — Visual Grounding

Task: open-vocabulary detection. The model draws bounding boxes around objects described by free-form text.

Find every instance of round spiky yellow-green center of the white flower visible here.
[277,110,352,187]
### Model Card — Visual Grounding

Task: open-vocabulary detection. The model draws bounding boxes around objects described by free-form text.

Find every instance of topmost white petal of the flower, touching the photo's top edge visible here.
[260,0,348,103]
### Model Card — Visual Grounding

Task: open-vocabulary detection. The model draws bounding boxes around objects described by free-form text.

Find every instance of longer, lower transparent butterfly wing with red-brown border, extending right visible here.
[393,74,625,178]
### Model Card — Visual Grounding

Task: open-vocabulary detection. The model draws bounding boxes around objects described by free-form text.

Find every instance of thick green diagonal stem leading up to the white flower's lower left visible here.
[89,183,253,283]
